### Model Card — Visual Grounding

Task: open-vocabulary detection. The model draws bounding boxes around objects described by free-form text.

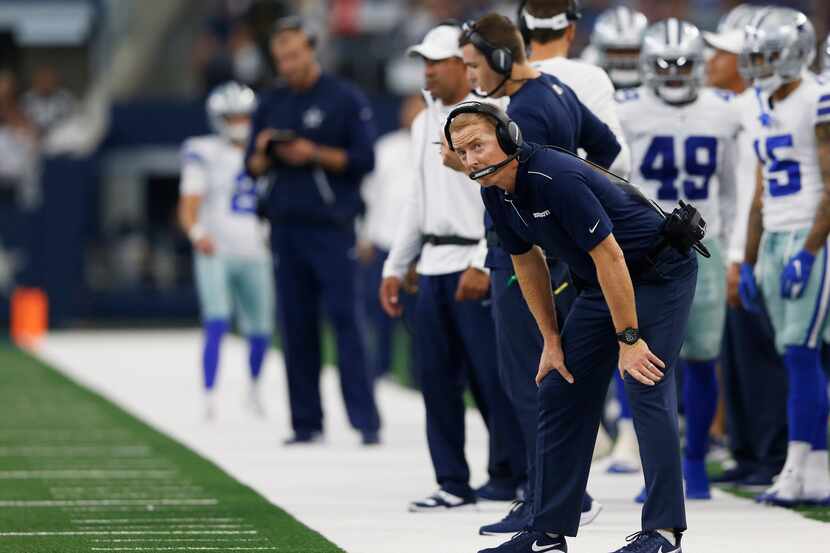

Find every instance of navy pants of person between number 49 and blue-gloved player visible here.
[721,302,789,478]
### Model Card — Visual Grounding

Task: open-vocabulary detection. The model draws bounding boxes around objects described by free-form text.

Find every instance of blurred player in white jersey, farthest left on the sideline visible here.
[179,82,274,418]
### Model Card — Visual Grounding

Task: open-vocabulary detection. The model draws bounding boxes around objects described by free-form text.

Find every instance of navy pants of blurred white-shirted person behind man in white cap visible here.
[358,247,394,378]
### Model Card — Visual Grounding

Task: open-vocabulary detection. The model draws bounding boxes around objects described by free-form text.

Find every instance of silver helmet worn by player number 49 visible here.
[640,17,706,104]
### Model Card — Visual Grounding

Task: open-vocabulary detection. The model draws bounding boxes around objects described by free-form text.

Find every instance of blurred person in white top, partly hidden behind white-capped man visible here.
[357,94,424,377]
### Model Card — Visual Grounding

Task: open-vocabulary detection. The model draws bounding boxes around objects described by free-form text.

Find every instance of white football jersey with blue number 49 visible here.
[616,86,741,238]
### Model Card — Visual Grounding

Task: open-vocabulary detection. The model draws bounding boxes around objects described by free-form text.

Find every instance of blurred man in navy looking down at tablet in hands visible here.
[245,17,380,444]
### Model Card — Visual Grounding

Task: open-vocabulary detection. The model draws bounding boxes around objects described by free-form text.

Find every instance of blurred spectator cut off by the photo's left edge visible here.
[0,70,39,206]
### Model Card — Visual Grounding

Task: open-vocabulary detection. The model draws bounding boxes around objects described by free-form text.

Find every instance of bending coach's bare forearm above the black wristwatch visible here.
[590,235,638,332]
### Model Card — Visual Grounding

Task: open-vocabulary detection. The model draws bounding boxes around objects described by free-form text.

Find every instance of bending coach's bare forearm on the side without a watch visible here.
[511,247,559,340]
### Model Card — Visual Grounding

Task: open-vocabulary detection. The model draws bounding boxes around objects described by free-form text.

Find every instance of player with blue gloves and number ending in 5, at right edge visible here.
[739,8,830,505]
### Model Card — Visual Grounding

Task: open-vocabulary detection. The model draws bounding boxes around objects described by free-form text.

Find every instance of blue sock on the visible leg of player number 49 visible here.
[683,360,718,461]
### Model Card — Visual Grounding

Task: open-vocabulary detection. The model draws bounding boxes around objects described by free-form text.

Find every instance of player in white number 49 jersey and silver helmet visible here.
[617,18,741,499]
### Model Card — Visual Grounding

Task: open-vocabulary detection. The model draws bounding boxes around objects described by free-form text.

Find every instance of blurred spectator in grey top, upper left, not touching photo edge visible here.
[23,65,76,136]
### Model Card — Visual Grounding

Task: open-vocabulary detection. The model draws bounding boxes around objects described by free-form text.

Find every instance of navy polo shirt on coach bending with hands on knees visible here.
[481,144,663,286]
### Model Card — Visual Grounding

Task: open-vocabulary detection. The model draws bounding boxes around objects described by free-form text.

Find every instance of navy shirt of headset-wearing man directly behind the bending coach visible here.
[484,73,621,269]
